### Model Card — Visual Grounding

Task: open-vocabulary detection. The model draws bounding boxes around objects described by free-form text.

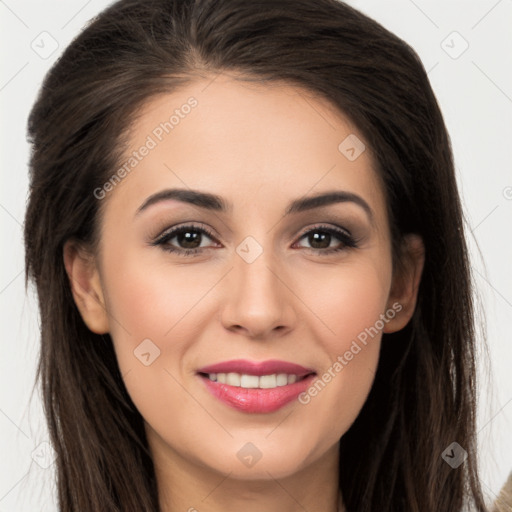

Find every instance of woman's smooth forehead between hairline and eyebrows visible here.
[102,74,384,222]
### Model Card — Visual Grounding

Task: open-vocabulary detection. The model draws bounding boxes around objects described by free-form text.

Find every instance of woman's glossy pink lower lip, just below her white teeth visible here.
[200,374,315,414]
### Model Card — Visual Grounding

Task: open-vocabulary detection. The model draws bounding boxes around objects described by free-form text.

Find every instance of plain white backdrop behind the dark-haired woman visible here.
[0,0,512,512]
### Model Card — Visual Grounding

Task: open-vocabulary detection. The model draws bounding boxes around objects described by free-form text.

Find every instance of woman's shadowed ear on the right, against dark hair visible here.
[383,234,425,332]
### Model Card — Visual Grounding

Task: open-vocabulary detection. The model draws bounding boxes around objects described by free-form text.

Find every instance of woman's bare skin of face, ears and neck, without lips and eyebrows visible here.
[64,73,423,512]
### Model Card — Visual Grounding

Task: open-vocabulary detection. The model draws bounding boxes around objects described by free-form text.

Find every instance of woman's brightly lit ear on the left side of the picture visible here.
[63,240,109,334]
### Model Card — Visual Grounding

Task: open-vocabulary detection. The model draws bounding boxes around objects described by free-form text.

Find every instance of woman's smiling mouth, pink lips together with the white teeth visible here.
[197,360,316,414]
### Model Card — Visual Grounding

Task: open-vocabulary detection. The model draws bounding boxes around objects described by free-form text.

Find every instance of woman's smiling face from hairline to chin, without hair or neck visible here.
[69,74,420,479]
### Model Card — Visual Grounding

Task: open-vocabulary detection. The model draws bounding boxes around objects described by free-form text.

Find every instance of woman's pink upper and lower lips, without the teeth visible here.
[198,359,316,414]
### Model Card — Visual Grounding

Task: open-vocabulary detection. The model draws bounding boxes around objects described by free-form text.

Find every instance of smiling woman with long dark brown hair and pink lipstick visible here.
[25,0,492,512]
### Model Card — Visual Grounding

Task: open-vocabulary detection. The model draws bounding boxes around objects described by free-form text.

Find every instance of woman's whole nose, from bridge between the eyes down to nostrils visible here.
[222,237,294,336]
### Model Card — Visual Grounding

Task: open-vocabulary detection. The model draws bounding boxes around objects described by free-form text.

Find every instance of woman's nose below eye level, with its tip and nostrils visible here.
[221,255,297,340]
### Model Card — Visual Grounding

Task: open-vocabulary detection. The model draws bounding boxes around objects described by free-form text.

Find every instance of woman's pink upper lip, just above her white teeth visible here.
[198,359,315,377]
